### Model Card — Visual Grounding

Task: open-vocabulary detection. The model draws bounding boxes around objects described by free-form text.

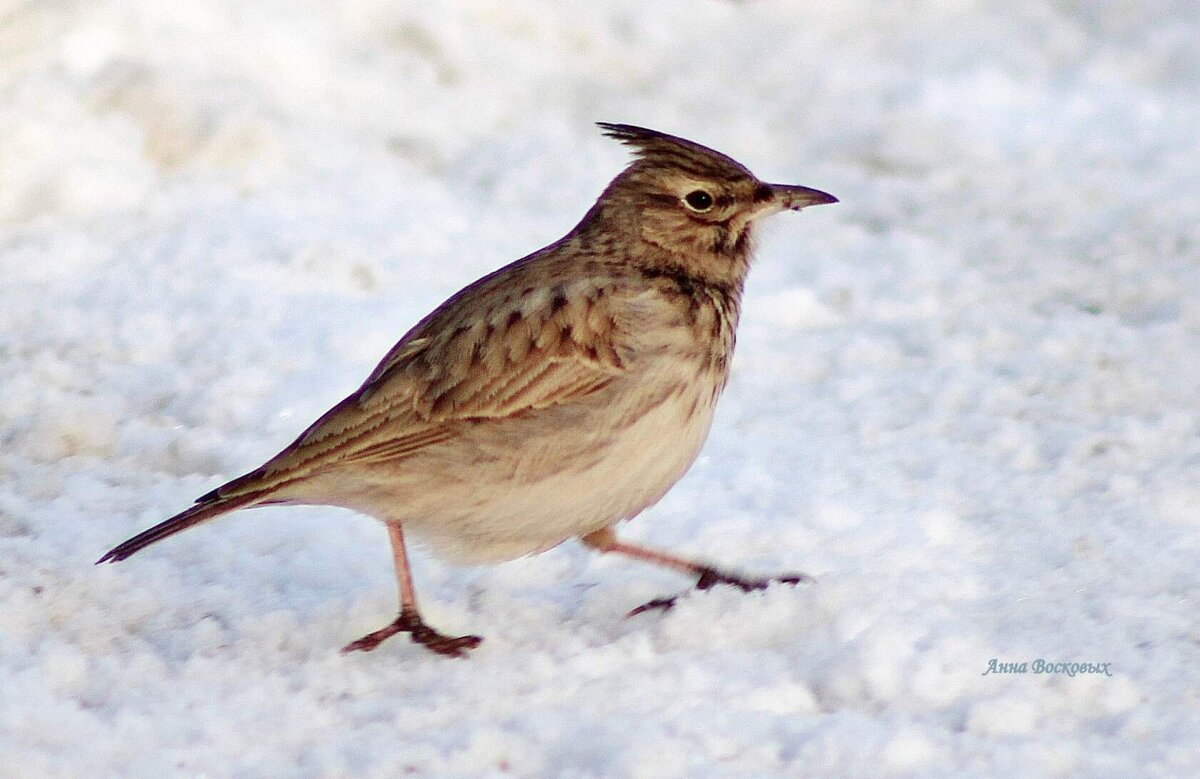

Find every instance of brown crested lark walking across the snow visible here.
[97,122,838,657]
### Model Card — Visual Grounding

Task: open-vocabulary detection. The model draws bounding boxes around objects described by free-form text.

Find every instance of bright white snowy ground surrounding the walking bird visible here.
[0,0,1200,777]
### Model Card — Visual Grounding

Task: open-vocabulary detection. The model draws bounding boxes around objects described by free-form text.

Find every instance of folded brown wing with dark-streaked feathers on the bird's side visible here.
[222,276,631,495]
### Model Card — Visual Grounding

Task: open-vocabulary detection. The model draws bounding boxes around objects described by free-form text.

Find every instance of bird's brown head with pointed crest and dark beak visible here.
[588,122,838,285]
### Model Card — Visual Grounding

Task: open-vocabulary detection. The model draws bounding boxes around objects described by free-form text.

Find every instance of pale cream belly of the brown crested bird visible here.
[319,369,715,563]
